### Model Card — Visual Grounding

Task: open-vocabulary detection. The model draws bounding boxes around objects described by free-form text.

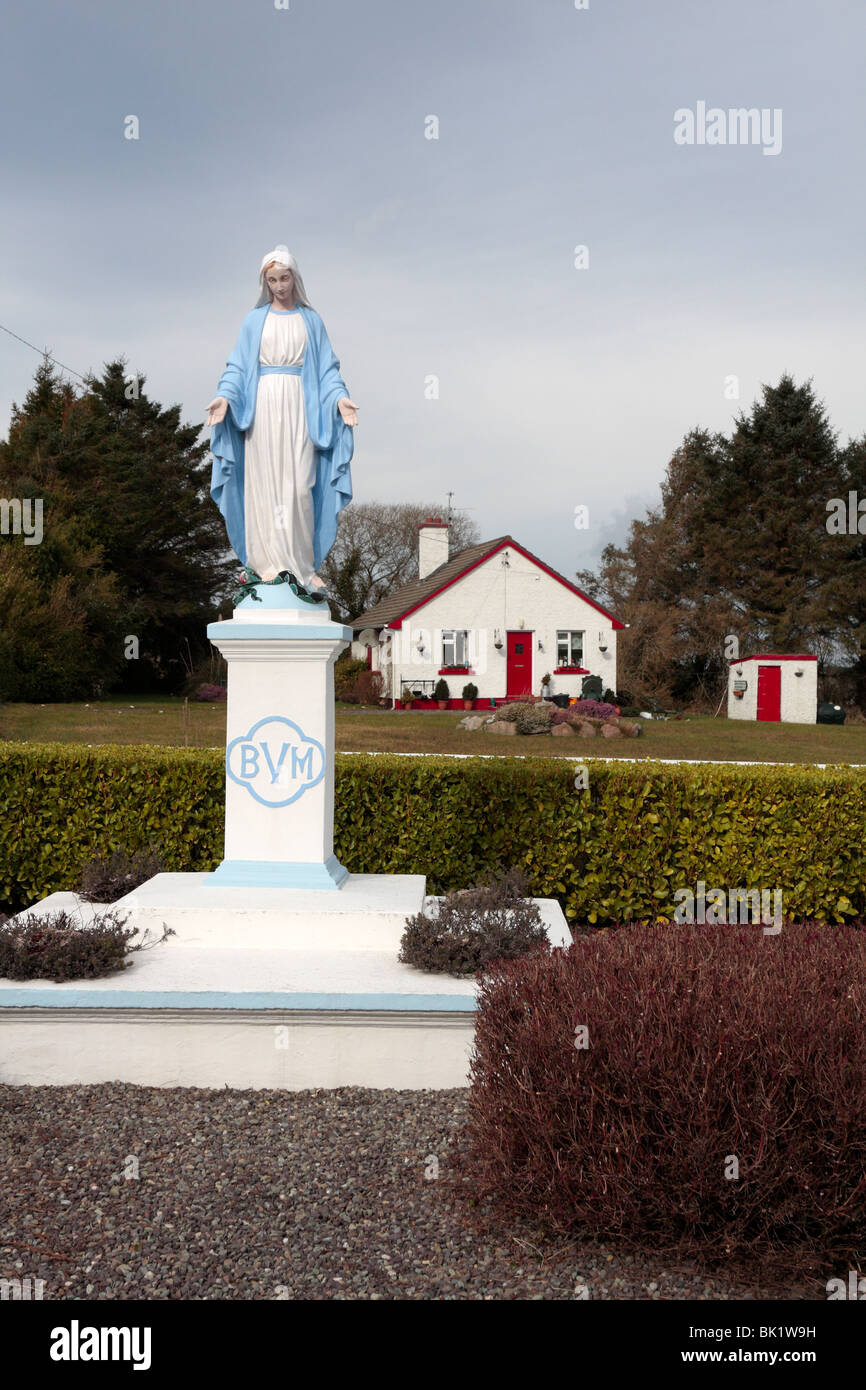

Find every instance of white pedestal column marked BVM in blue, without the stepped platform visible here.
[207,584,352,890]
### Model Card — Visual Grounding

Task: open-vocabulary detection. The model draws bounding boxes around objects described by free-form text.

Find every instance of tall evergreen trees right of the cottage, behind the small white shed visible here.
[577,374,866,701]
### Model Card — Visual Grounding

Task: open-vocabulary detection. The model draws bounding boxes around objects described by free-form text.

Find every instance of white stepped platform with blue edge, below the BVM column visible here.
[0,874,571,1090]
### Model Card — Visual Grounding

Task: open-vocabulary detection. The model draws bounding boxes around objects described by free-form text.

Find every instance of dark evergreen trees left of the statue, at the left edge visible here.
[0,361,232,699]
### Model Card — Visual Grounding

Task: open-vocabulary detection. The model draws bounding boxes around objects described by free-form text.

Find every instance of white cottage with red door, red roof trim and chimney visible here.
[349,517,624,709]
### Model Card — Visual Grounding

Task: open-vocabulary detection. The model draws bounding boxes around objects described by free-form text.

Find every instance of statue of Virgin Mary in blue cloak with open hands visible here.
[207,246,357,594]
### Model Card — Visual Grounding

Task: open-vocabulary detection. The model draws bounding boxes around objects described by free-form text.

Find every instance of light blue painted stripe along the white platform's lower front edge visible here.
[0,987,475,1013]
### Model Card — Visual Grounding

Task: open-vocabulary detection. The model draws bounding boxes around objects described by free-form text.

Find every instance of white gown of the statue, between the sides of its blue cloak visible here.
[243,309,316,587]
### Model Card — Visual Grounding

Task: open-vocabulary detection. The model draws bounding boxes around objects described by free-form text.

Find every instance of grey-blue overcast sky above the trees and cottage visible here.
[0,0,866,575]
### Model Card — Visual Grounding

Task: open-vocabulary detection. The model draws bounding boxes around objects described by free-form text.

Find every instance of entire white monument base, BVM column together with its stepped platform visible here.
[0,585,571,1090]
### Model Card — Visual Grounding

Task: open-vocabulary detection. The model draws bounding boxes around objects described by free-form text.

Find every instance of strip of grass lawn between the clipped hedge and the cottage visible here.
[0,695,866,765]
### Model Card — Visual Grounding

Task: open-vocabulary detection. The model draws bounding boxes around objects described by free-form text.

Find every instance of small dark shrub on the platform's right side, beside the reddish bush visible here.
[399,869,550,976]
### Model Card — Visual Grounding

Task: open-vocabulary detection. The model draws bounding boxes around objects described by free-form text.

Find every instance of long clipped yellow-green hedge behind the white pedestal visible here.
[0,744,866,926]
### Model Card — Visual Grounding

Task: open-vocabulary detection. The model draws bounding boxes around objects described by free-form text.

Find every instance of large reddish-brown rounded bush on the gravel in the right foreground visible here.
[457,923,866,1261]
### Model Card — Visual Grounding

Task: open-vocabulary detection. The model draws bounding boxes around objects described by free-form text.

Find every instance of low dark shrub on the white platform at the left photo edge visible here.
[0,912,175,983]
